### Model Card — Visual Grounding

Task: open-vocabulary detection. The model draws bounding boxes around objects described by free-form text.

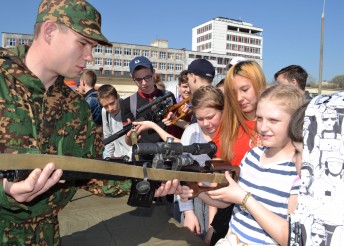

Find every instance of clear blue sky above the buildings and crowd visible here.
[0,0,344,82]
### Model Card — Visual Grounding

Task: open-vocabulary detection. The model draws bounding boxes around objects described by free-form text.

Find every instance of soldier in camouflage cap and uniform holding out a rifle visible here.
[0,0,180,245]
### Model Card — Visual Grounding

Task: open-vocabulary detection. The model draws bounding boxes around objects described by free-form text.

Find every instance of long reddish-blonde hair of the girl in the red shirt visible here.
[219,61,266,161]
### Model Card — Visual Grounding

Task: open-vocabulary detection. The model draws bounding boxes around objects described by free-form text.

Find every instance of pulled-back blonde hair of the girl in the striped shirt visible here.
[258,85,305,115]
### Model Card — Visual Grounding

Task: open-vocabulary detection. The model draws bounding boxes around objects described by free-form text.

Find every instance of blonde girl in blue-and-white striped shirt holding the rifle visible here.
[182,85,304,245]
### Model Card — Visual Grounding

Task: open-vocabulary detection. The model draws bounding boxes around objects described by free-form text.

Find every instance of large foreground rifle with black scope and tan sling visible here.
[0,139,234,207]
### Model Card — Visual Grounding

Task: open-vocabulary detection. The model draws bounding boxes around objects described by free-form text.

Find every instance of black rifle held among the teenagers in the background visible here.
[103,91,173,145]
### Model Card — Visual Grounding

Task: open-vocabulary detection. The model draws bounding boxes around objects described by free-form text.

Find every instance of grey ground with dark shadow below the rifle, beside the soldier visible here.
[59,190,205,246]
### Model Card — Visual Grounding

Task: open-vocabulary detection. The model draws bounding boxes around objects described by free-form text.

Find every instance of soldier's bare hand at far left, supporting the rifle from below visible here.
[2,163,62,202]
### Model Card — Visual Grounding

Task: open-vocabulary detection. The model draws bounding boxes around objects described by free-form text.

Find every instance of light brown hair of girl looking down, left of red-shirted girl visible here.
[191,85,224,111]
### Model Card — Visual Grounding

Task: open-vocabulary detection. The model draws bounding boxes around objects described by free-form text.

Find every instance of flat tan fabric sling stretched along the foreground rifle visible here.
[0,154,228,184]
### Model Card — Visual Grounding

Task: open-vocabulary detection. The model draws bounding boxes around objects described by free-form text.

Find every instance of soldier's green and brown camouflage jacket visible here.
[0,46,130,245]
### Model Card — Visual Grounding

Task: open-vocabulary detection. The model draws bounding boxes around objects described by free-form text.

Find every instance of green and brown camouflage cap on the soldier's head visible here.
[36,0,112,46]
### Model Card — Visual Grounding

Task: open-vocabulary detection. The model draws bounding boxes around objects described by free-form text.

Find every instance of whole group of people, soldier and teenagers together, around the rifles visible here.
[0,0,344,246]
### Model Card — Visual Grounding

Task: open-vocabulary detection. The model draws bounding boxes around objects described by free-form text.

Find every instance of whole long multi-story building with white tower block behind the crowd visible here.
[2,18,263,95]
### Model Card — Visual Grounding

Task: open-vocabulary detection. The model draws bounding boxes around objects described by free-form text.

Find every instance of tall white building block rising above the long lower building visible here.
[192,17,263,60]
